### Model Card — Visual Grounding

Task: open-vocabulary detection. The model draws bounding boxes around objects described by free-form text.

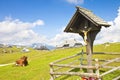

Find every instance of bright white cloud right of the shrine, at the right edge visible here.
[95,8,120,43]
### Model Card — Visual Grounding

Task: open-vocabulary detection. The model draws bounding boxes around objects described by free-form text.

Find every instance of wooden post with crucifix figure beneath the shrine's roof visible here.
[79,20,100,73]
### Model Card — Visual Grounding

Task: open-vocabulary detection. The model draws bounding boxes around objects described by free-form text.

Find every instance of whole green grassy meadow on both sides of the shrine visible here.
[0,43,120,80]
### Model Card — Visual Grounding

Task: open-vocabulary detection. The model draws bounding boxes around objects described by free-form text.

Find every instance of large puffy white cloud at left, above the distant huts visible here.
[0,17,46,45]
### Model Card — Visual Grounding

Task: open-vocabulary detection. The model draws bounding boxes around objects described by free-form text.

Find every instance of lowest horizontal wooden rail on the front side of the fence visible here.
[50,72,98,78]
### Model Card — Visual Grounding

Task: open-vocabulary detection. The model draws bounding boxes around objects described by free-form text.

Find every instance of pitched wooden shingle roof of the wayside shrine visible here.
[64,6,110,32]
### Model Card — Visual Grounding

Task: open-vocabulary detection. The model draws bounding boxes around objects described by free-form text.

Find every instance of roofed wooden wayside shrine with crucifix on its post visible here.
[64,6,110,73]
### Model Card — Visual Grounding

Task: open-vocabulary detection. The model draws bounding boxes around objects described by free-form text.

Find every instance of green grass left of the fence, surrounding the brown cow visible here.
[0,48,79,80]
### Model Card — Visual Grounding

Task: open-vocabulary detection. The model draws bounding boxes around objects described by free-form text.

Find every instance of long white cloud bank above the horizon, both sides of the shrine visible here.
[0,8,120,46]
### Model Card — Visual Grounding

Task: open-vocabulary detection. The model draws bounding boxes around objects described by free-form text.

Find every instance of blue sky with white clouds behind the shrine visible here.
[0,0,120,46]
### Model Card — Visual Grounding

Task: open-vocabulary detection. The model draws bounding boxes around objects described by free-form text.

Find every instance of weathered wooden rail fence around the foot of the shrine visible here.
[50,53,120,80]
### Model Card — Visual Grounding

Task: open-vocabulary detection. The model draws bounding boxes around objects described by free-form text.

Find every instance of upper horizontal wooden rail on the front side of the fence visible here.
[52,64,97,69]
